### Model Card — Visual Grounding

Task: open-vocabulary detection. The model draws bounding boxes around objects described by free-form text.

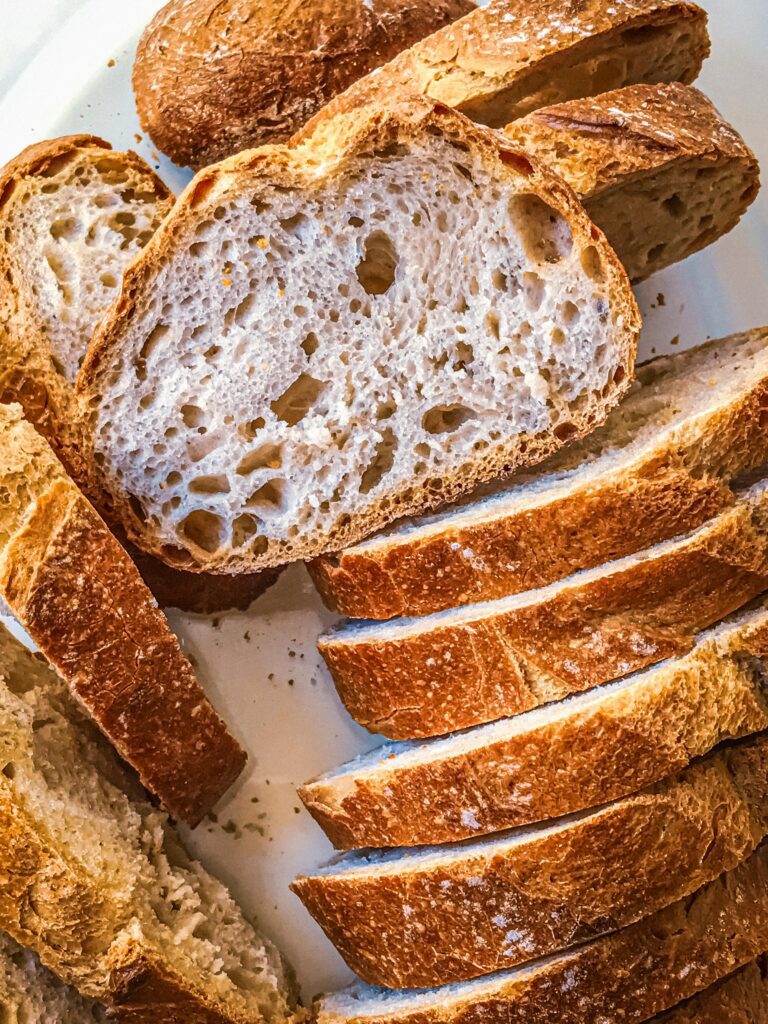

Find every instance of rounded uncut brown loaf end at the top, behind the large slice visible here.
[133,0,475,168]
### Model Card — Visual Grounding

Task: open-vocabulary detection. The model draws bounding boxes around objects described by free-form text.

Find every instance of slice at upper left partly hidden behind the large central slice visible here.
[0,135,275,612]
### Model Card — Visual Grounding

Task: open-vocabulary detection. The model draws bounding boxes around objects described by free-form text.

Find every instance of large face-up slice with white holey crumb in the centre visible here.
[78,97,639,571]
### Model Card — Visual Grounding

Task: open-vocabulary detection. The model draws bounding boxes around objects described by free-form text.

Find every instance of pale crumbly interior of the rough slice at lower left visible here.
[0,630,290,1021]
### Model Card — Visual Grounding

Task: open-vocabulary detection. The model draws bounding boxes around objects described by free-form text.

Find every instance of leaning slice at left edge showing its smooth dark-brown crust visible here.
[0,406,246,824]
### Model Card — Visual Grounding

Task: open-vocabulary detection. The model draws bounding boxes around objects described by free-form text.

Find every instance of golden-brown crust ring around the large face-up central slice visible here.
[78,95,640,572]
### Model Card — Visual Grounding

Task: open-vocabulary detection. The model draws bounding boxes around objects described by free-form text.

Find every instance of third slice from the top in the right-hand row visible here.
[299,603,768,850]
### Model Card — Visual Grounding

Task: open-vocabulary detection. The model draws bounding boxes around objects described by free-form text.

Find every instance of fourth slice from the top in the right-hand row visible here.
[293,735,768,988]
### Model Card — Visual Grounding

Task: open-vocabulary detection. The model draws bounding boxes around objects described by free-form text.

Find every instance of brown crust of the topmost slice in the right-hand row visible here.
[309,328,768,618]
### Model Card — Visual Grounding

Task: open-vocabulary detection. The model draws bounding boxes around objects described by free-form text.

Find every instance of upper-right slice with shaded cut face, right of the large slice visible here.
[505,83,760,281]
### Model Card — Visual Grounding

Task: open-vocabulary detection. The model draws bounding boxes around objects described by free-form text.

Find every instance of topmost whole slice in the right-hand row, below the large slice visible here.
[310,328,768,618]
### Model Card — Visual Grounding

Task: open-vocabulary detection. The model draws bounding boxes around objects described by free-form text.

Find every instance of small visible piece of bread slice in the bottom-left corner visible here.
[0,935,106,1024]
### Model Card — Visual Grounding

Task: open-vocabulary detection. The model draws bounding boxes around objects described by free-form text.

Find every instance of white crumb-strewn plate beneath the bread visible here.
[0,0,768,996]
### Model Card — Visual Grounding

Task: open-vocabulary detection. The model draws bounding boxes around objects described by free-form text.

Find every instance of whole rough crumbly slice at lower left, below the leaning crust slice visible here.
[0,618,299,1024]
